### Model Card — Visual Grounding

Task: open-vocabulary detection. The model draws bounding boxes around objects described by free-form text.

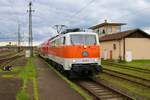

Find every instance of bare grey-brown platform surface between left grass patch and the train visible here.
[36,58,84,100]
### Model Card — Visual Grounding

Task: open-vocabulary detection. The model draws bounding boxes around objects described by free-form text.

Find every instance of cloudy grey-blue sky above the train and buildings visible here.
[0,0,150,42]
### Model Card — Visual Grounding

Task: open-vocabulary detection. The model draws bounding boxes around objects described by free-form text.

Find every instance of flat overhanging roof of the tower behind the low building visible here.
[89,22,126,29]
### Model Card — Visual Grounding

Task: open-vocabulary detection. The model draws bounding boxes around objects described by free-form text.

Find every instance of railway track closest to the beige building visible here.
[104,62,150,74]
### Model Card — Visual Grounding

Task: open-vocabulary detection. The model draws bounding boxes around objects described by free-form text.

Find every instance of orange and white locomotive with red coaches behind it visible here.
[39,29,102,78]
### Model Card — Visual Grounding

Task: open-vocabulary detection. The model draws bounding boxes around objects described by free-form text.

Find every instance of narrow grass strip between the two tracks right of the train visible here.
[103,65,150,80]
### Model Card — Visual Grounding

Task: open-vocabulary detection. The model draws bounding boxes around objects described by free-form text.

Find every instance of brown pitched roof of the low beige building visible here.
[99,29,150,41]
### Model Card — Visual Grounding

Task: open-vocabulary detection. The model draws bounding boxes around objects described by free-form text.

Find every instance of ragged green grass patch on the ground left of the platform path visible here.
[17,58,38,100]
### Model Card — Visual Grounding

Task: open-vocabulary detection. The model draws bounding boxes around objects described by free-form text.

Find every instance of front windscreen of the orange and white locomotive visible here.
[70,34,97,45]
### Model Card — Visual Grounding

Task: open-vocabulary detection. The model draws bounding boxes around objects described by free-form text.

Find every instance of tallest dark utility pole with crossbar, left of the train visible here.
[28,1,34,57]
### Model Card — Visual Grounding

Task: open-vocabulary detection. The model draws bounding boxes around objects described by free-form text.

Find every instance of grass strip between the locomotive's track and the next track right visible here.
[99,74,150,100]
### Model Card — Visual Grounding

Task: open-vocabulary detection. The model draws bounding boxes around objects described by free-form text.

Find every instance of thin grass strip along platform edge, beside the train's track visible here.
[43,59,92,100]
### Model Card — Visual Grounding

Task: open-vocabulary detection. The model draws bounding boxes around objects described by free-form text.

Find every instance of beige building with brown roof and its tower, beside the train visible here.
[90,21,150,60]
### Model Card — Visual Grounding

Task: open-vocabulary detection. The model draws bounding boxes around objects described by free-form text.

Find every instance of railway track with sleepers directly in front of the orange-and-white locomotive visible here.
[74,80,133,100]
